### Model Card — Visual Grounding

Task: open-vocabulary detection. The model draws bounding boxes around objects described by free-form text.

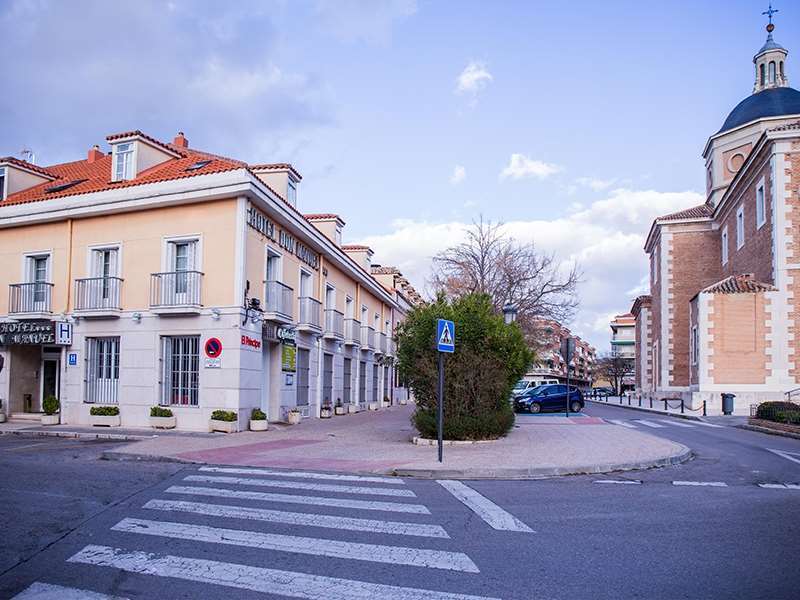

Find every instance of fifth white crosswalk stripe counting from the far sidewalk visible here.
[111,518,480,573]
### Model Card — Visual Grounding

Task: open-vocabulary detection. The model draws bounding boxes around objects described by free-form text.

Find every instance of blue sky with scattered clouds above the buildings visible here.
[0,0,800,352]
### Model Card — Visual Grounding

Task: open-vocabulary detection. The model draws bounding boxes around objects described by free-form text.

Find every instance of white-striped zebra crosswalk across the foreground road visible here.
[17,467,533,600]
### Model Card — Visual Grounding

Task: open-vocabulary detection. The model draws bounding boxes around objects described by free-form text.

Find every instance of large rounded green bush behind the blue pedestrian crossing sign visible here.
[397,294,533,440]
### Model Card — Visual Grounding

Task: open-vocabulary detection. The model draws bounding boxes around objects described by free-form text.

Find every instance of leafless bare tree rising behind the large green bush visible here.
[431,217,580,333]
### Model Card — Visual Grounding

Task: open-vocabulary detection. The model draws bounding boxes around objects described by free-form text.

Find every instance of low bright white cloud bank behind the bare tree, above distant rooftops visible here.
[361,189,704,352]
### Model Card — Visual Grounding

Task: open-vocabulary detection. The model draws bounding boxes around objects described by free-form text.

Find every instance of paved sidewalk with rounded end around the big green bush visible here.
[54,405,691,479]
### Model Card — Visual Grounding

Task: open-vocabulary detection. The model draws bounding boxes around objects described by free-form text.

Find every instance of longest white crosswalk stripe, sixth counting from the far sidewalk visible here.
[69,545,497,600]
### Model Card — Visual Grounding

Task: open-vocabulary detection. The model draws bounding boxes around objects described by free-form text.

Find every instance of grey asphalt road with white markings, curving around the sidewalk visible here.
[0,412,800,600]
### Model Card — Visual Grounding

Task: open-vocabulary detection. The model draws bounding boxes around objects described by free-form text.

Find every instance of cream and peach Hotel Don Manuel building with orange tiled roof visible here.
[0,131,419,431]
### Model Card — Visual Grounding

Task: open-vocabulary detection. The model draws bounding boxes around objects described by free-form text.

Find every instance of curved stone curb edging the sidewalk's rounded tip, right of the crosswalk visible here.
[391,445,693,479]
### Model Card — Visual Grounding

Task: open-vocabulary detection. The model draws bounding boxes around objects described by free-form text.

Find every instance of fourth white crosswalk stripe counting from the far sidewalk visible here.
[144,500,450,538]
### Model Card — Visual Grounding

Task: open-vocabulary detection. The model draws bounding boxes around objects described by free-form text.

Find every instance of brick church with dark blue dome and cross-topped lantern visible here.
[632,18,800,414]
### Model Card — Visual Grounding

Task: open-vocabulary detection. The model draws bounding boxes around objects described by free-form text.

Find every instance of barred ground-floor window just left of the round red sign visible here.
[161,335,200,406]
